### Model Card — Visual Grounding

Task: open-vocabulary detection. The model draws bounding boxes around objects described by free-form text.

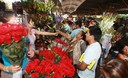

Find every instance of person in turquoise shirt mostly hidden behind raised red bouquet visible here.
[0,11,31,78]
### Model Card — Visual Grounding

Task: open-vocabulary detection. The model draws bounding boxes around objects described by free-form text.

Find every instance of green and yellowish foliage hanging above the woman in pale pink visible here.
[21,0,53,29]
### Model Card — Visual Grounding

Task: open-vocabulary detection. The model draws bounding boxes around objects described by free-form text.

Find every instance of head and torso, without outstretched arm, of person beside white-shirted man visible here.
[72,31,86,65]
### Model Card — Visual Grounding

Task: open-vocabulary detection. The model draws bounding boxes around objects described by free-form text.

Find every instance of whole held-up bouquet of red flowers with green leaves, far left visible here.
[0,23,28,65]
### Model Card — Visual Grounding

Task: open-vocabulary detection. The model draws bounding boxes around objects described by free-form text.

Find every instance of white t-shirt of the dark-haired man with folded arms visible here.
[78,42,101,78]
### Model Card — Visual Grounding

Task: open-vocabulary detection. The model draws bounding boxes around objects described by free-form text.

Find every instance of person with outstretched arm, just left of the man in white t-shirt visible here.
[57,30,87,65]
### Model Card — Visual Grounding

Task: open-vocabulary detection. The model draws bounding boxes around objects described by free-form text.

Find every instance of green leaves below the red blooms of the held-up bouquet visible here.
[1,37,27,65]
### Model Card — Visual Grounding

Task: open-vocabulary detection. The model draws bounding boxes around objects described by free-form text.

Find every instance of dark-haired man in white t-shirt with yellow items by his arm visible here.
[76,26,102,78]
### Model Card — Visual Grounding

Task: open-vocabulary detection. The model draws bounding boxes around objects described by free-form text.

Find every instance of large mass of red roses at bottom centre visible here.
[26,46,75,78]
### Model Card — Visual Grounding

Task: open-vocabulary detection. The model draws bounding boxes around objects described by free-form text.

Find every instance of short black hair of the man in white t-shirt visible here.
[89,26,102,41]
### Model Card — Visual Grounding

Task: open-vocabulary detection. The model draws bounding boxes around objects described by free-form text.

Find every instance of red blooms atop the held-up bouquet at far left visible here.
[0,23,28,45]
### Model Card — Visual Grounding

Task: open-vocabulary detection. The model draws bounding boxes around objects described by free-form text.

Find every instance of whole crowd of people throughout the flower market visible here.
[0,12,128,78]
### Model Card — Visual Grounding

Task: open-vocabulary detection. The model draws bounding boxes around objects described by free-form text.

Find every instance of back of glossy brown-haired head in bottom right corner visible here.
[102,59,128,78]
